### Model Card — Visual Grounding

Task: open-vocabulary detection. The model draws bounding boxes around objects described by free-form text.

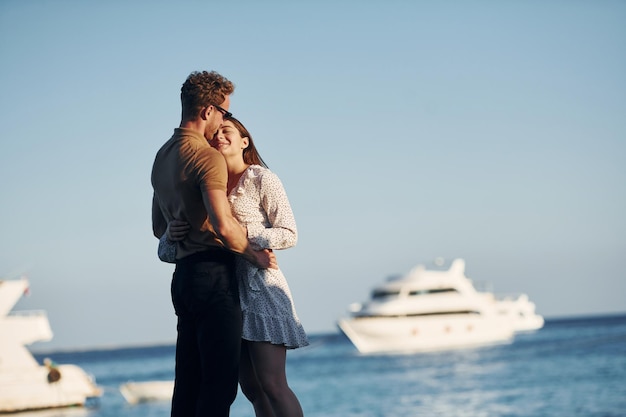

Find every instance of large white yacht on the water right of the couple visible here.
[337,259,543,353]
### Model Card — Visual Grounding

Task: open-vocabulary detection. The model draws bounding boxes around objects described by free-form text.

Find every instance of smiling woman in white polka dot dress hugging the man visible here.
[159,117,309,417]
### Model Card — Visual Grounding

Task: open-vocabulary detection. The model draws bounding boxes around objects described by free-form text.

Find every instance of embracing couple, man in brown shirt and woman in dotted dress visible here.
[152,71,308,417]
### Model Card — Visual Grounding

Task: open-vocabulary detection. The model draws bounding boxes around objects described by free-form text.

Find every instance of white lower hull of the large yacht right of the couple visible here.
[338,314,514,353]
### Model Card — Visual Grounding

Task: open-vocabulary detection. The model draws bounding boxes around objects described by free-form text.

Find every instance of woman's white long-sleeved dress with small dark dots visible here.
[228,165,309,349]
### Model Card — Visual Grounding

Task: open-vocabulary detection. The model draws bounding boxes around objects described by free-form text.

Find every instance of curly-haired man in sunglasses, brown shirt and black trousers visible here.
[152,71,276,417]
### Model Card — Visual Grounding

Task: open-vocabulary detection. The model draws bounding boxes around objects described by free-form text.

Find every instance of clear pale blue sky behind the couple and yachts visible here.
[0,0,626,348]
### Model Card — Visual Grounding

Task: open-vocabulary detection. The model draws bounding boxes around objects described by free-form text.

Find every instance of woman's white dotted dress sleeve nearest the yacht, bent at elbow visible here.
[248,171,298,249]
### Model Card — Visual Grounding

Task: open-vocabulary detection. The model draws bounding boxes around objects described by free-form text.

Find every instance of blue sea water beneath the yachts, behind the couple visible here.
[29,315,626,417]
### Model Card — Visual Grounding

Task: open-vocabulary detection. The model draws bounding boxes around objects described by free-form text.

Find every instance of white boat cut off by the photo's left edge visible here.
[0,278,102,414]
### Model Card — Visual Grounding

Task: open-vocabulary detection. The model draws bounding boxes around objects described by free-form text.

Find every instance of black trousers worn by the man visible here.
[171,249,241,417]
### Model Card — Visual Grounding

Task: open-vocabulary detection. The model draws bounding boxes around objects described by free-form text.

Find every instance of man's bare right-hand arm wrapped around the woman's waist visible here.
[204,190,277,268]
